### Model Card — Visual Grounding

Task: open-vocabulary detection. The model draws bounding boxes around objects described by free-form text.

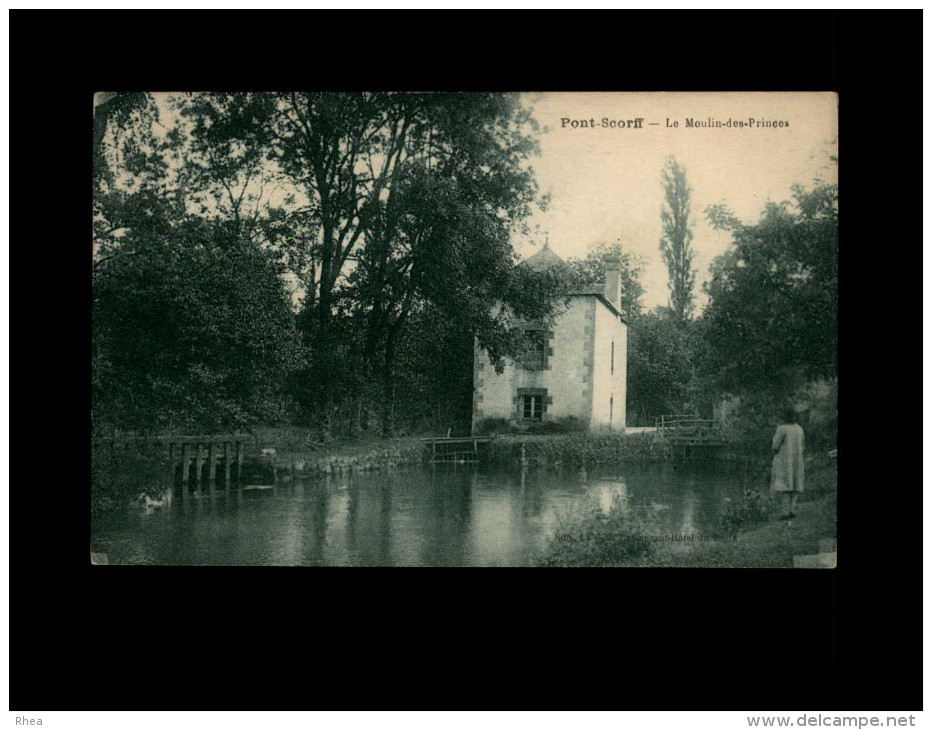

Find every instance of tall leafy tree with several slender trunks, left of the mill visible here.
[220,93,549,430]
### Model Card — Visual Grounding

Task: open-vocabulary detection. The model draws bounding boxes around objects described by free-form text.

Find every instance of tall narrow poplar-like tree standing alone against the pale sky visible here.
[660,157,696,322]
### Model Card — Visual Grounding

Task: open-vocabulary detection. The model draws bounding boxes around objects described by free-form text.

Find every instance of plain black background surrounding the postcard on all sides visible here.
[9,11,922,711]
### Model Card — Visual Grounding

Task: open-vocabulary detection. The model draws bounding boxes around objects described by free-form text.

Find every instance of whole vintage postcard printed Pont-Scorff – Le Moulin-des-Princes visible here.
[88,91,839,570]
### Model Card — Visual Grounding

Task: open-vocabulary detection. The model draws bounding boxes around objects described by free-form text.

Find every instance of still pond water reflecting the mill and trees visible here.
[91,462,743,566]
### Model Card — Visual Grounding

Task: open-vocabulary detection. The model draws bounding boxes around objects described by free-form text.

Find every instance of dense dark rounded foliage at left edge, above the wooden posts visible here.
[93,231,305,430]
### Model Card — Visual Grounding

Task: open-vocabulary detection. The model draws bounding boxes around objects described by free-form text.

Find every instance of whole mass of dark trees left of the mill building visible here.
[94,93,560,438]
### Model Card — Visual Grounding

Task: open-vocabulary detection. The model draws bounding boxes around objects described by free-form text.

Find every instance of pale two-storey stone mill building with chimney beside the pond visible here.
[473,246,628,431]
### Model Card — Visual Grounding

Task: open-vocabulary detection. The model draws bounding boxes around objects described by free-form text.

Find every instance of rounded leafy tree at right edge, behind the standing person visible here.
[703,183,838,391]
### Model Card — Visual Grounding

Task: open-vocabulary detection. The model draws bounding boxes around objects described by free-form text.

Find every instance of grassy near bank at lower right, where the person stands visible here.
[539,454,837,568]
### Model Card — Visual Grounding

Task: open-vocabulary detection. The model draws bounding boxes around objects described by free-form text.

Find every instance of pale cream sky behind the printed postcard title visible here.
[515,92,838,309]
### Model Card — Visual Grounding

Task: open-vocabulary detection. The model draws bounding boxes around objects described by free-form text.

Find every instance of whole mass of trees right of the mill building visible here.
[628,173,838,430]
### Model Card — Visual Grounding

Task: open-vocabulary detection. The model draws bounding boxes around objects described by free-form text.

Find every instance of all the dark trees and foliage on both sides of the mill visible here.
[93,93,837,439]
